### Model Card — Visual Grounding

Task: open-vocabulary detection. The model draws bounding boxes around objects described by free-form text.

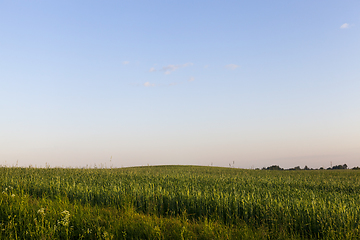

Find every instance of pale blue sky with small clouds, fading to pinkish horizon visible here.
[0,0,360,168]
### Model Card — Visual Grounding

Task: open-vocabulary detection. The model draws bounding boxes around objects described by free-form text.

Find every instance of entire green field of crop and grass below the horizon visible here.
[0,166,360,239]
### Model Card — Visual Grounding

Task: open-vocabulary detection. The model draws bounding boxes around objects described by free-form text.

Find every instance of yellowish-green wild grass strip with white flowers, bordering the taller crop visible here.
[0,193,285,239]
